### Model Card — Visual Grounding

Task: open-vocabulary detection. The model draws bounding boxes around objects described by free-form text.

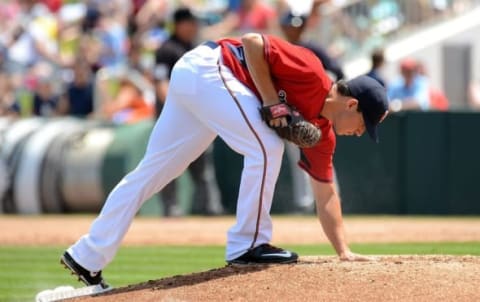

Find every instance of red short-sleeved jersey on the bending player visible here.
[217,35,335,182]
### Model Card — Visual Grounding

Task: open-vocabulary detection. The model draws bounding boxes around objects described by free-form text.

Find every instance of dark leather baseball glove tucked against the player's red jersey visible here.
[260,103,322,148]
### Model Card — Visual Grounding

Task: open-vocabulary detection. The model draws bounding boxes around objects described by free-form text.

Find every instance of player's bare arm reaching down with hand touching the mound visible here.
[311,178,372,261]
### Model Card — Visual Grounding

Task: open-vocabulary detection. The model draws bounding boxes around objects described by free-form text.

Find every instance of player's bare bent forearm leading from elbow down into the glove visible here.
[242,33,287,127]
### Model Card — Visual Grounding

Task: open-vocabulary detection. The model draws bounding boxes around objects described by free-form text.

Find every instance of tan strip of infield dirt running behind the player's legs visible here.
[0,216,480,246]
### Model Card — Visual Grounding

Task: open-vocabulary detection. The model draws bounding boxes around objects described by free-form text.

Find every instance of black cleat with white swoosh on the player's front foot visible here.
[227,243,298,264]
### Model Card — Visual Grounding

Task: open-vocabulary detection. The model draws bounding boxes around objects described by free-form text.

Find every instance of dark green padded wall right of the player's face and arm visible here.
[335,112,480,215]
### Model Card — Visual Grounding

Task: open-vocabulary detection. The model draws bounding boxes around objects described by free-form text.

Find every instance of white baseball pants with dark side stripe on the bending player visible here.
[68,45,284,271]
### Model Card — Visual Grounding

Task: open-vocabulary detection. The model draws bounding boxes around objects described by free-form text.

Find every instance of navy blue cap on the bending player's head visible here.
[347,75,388,143]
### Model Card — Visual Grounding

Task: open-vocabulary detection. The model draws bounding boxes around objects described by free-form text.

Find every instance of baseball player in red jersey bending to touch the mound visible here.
[61,33,387,285]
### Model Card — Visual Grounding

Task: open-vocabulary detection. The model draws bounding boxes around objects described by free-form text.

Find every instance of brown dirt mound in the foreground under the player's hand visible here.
[74,256,480,302]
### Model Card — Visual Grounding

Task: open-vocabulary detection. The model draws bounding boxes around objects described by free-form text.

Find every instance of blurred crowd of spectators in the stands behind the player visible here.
[0,0,478,123]
